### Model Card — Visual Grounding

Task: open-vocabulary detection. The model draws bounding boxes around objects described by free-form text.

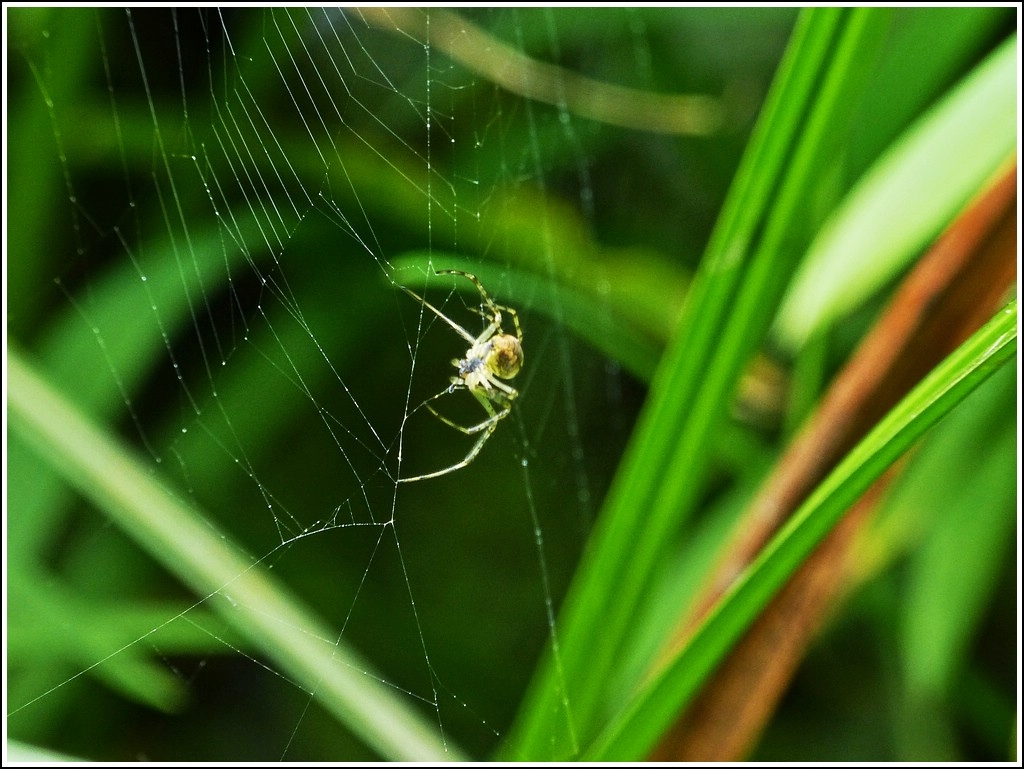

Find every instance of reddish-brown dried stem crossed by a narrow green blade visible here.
[653,165,1017,761]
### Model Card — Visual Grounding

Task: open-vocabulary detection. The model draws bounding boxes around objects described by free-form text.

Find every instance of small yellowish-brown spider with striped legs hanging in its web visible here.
[398,269,522,483]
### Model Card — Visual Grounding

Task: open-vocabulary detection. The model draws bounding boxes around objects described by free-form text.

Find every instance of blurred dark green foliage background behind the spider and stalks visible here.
[5,8,1019,761]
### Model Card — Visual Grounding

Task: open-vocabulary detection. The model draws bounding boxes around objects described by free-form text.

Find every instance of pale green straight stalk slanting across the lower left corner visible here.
[7,350,459,761]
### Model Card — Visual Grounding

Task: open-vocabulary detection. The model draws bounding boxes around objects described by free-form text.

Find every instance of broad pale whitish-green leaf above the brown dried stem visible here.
[776,37,1017,348]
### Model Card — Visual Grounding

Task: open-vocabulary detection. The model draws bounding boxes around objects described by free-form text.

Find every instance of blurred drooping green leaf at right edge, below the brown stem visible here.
[899,360,1019,700]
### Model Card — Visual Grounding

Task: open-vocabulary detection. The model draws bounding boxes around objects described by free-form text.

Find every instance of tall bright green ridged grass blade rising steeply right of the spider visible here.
[506,9,888,760]
